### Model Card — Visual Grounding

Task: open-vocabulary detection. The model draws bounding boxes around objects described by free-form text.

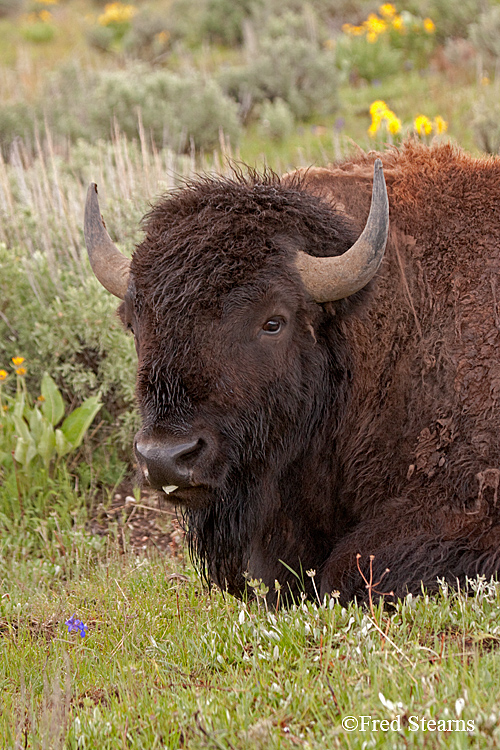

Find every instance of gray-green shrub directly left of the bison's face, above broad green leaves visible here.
[0,245,136,450]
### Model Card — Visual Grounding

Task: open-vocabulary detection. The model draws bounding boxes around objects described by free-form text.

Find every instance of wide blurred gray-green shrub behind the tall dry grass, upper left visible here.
[0,63,240,153]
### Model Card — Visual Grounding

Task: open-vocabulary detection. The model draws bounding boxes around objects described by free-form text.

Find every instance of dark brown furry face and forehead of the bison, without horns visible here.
[120,176,364,508]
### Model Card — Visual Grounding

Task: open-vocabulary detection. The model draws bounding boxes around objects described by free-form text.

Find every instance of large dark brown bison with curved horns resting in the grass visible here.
[85,142,500,602]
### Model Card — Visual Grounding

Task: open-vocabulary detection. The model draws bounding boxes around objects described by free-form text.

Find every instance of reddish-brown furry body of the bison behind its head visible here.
[290,143,500,592]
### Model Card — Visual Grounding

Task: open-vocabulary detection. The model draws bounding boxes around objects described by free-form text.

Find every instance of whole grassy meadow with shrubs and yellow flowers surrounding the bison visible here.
[0,0,500,750]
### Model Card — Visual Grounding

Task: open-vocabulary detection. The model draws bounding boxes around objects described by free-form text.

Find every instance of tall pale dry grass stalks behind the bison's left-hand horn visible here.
[0,130,219,278]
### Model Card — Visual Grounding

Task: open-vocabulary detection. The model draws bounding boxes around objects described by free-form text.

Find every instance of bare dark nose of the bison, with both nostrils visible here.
[135,438,205,489]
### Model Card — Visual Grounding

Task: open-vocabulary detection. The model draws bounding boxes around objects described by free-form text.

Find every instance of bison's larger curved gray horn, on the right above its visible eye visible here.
[296,159,389,302]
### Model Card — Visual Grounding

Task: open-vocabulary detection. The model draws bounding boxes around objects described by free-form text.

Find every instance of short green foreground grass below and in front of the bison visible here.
[0,535,500,750]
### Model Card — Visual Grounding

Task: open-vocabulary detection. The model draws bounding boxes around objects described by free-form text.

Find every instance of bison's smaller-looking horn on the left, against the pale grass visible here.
[83,182,130,299]
